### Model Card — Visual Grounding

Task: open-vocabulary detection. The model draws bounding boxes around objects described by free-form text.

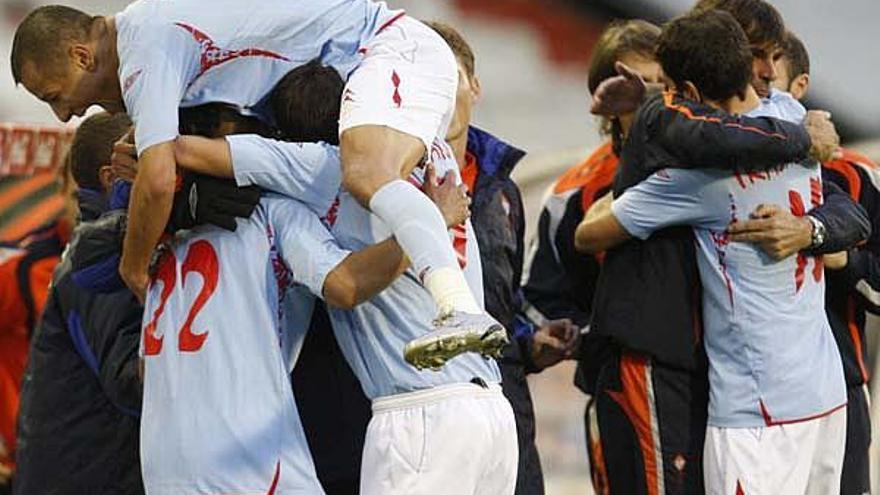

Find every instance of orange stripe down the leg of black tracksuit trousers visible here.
[608,354,665,495]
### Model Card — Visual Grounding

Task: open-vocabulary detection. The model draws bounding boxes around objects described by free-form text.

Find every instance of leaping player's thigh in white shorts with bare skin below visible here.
[339,17,458,201]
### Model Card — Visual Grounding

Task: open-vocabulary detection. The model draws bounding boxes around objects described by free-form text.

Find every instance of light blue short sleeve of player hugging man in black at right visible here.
[611,169,709,240]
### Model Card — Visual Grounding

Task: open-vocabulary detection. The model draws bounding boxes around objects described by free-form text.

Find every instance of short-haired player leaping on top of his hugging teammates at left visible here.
[11,0,506,368]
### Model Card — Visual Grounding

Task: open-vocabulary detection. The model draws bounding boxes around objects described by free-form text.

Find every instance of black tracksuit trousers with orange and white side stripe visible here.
[586,353,709,495]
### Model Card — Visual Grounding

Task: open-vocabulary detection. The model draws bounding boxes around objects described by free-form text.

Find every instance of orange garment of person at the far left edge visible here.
[0,222,69,488]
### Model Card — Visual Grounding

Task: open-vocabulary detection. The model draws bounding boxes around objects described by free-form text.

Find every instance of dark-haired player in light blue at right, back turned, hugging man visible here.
[577,10,846,494]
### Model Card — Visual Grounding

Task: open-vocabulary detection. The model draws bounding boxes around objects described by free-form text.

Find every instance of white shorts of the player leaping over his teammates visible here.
[339,15,458,154]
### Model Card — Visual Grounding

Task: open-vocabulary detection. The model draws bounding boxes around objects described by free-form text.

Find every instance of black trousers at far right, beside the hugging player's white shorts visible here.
[840,385,871,495]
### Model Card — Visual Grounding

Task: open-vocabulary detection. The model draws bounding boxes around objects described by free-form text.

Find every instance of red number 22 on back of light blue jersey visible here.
[144,240,220,356]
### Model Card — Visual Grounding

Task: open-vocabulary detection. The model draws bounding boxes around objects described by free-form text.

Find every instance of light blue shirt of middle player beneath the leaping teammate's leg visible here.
[227,135,501,399]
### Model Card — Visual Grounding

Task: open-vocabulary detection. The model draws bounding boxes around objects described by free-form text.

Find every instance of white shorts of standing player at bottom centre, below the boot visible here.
[361,384,519,495]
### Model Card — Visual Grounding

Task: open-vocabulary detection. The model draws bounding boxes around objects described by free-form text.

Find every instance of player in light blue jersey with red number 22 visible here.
[141,102,460,494]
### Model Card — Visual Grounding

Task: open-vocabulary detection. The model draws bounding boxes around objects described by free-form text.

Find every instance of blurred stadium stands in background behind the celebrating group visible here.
[0,0,880,495]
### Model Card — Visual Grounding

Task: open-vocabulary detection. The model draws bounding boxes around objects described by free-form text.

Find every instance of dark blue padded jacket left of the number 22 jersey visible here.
[13,185,143,495]
